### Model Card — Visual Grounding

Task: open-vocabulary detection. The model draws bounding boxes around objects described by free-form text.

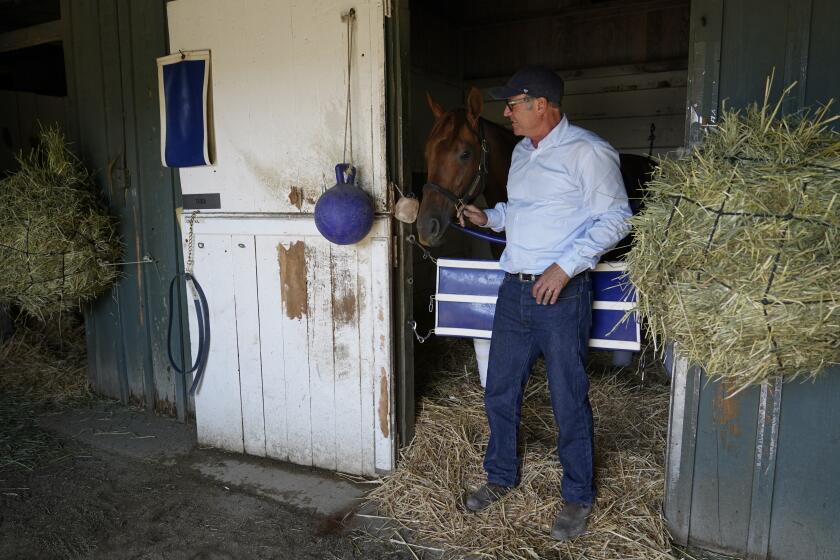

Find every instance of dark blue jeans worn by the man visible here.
[484,272,595,504]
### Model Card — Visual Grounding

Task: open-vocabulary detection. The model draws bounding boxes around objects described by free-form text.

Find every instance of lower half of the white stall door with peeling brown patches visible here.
[190,217,394,475]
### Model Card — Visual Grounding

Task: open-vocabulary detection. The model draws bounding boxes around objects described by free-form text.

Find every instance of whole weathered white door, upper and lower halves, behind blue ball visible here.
[168,0,394,474]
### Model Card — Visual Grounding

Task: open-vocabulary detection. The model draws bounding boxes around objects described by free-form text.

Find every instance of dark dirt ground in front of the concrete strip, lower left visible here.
[0,395,413,560]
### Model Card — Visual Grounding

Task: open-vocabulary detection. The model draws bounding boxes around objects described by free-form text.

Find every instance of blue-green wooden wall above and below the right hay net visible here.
[665,0,840,560]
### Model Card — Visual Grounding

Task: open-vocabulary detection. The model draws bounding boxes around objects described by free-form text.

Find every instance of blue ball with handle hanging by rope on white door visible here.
[315,163,373,245]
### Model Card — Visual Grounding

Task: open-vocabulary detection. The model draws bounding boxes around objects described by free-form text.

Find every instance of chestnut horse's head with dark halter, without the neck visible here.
[417,88,487,247]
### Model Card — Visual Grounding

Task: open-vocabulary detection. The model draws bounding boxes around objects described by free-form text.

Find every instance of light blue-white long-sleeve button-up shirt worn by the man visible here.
[485,116,632,277]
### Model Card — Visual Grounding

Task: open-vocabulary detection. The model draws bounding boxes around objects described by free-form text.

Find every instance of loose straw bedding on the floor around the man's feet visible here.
[369,341,676,560]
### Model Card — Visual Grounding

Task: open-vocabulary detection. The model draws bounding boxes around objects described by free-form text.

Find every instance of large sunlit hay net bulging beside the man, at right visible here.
[627,79,840,390]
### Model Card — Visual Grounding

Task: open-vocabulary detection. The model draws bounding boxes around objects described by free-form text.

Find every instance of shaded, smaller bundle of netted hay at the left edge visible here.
[0,128,122,317]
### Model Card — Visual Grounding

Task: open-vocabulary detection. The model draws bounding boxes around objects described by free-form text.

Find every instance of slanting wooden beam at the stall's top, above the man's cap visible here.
[462,0,691,31]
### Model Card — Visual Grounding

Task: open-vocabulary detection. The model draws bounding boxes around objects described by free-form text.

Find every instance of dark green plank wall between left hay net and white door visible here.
[61,0,188,418]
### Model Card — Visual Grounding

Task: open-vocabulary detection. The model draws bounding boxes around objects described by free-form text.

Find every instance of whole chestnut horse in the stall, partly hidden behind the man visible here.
[417,87,654,260]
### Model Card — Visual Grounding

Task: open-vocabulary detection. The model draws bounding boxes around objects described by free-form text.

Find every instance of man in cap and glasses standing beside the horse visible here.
[461,66,631,540]
